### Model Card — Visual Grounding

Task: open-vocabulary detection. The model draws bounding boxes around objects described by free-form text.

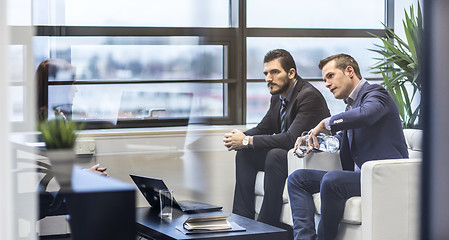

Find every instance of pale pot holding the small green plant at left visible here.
[47,149,76,191]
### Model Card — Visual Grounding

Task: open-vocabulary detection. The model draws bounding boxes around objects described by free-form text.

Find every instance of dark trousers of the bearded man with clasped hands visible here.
[232,148,288,227]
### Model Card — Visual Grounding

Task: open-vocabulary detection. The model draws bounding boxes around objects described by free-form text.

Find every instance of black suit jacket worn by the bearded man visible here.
[245,77,330,150]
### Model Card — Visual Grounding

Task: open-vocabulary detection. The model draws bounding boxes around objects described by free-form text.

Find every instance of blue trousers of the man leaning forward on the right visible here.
[287,169,360,240]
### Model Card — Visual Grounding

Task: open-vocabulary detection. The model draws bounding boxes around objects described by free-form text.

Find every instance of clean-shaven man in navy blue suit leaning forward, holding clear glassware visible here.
[288,54,408,240]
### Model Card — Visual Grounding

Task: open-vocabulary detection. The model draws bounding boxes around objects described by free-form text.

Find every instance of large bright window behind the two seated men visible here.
[245,0,391,123]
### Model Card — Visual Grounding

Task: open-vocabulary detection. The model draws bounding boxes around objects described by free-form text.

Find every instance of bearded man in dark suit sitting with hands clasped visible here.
[223,49,330,227]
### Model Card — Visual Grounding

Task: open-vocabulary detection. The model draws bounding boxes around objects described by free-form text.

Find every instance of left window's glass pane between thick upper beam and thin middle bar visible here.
[35,37,224,81]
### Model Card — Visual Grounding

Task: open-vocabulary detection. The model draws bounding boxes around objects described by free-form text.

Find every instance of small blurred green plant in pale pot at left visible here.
[39,119,79,190]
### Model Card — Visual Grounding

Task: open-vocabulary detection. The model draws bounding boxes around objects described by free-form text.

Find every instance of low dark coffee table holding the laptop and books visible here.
[136,207,287,240]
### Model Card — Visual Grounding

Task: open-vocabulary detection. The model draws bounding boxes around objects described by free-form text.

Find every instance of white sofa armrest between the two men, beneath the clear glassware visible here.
[287,149,341,175]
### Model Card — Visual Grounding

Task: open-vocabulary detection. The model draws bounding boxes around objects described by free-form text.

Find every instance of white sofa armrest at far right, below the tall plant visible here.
[361,159,421,240]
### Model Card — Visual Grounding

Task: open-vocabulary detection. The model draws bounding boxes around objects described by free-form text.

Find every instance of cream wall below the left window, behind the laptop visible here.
[76,126,242,211]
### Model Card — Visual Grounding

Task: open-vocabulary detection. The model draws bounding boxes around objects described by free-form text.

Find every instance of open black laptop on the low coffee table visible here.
[129,174,223,213]
